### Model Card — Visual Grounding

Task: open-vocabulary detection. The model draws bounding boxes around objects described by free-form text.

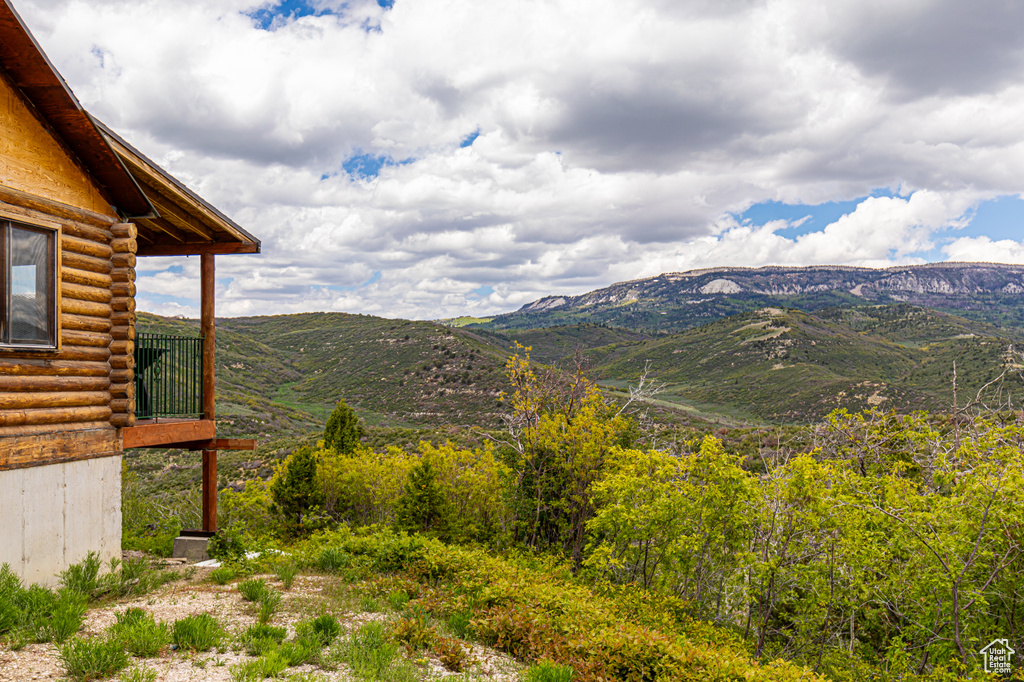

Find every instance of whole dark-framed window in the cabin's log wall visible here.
[0,221,57,348]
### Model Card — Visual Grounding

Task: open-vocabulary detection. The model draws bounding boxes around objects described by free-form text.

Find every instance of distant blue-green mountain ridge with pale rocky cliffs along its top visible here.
[477,262,1024,332]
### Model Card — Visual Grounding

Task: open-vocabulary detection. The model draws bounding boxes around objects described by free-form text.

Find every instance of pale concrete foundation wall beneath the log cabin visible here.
[0,456,121,585]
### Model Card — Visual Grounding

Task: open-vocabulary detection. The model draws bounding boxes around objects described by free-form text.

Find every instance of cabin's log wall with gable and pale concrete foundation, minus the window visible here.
[0,62,125,584]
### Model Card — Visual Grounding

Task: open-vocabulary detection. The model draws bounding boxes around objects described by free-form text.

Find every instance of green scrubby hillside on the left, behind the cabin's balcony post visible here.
[139,313,505,431]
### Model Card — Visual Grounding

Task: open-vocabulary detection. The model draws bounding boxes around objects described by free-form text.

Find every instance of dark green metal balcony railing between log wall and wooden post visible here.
[135,334,203,419]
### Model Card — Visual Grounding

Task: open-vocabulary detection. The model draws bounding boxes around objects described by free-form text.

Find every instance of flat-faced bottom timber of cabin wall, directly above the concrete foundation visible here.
[0,422,121,470]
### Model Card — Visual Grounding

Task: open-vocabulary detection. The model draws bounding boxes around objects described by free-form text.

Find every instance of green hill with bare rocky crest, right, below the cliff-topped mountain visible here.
[591,305,1024,421]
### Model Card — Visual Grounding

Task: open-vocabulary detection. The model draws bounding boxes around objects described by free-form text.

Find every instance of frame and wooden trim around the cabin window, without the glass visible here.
[0,210,61,355]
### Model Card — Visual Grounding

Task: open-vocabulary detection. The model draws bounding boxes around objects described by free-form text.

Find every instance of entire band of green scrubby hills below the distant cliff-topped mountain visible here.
[139,304,1024,438]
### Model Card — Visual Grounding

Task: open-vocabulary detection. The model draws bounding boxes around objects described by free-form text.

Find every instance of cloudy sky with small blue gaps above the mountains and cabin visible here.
[11,0,1024,319]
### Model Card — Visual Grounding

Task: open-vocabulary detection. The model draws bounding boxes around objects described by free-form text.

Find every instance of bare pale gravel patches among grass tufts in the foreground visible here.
[0,569,522,682]
